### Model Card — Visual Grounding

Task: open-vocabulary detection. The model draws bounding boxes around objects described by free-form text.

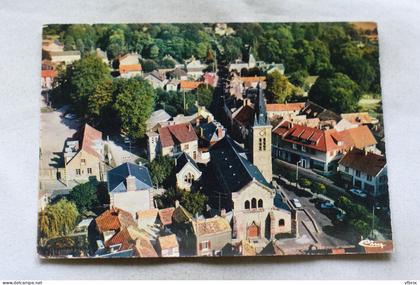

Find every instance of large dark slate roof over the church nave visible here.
[210,135,271,193]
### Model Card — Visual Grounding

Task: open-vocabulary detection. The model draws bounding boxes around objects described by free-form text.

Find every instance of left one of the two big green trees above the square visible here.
[66,54,111,115]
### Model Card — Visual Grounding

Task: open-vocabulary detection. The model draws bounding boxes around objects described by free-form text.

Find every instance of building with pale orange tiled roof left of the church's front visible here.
[191,216,232,256]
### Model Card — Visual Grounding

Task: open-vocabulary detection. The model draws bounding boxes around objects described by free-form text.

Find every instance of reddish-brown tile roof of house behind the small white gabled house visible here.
[159,123,198,147]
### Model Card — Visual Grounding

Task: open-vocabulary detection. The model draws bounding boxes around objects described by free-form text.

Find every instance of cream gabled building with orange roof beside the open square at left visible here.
[62,124,106,184]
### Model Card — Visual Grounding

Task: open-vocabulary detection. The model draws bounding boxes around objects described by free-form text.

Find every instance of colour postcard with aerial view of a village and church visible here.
[34,22,393,258]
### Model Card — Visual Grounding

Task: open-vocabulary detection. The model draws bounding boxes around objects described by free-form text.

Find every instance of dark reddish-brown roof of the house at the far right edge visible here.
[339,148,386,177]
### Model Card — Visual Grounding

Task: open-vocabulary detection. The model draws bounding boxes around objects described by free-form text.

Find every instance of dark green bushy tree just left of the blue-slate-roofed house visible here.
[68,182,98,213]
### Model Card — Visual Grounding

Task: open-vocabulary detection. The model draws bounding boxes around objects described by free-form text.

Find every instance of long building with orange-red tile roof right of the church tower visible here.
[272,118,376,173]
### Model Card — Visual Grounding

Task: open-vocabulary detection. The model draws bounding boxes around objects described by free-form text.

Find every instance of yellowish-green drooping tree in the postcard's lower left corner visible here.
[38,199,79,238]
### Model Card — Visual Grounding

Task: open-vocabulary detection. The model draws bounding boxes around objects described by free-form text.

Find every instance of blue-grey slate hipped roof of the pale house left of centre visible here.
[108,162,153,193]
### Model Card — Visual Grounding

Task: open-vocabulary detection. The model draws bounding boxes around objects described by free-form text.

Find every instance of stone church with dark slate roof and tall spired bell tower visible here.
[207,89,292,242]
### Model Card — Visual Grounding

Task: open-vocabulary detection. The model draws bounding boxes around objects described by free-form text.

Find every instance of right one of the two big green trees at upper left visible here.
[114,78,156,139]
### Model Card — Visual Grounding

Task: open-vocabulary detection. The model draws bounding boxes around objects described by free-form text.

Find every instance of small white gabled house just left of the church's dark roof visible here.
[175,152,202,190]
